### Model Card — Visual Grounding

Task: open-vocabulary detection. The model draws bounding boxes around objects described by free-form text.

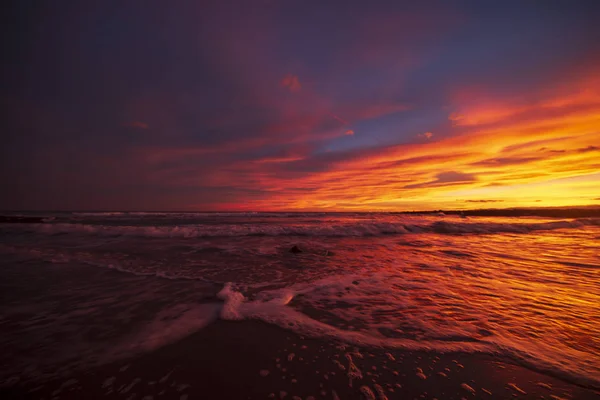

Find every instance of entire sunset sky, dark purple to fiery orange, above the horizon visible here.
[0,0,600,211]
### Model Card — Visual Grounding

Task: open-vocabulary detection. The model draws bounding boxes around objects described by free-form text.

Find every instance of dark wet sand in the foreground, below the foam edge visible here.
[0,320,600,400]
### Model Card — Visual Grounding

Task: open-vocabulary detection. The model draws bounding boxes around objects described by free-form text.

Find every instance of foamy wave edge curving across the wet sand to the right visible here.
[217,282,600,389]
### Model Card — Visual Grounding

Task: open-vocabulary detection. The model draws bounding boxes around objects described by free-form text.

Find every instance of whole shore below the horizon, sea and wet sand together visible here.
[0,213,600,400]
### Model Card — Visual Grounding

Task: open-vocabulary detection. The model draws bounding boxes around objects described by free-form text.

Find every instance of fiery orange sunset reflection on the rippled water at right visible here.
[284,217,600,384]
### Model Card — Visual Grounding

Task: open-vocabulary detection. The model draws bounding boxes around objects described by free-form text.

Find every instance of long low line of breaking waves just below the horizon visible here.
[0,218,600,238]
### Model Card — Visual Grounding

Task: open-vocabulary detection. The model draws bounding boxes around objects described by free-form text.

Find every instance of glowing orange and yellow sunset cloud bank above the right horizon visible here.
[220,71,600,210]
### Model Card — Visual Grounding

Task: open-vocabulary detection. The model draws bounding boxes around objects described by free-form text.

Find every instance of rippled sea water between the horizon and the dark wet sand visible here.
[0,213,600,387]
